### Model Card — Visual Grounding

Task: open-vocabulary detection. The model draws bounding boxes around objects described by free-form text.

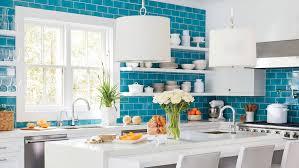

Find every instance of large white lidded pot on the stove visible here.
[267,103,289,124]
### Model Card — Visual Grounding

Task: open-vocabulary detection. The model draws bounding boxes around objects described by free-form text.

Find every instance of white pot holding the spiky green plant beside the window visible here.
[101,107,117,126]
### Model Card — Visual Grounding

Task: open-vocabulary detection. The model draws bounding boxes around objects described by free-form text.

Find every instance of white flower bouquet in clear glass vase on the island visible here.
[153,90,194,140]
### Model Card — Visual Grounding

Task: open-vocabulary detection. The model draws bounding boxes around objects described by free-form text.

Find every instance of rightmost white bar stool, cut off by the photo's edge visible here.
[272,141,299,168]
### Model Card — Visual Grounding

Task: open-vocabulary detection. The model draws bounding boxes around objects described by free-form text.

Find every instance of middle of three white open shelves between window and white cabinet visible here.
[120,67,209,74]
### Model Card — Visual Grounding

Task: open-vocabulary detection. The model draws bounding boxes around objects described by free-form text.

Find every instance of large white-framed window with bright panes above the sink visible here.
[16,7,119,121]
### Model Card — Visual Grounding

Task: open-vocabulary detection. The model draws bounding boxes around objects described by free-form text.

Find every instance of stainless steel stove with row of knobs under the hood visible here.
[238,121,299,139]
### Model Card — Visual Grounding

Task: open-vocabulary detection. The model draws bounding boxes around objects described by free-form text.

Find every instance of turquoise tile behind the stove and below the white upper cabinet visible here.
[216,68,299,123]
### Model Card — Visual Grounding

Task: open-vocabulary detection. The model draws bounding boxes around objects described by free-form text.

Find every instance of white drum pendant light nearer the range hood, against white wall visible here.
[209,10,256,67]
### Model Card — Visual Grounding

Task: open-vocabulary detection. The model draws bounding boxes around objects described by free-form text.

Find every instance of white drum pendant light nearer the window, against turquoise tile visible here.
[114,0,171,62]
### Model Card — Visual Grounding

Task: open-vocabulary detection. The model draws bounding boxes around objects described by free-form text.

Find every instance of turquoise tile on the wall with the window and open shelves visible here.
[0,0,210,127]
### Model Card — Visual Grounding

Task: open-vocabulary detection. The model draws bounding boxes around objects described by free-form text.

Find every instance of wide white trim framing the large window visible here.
[15,6,120,122]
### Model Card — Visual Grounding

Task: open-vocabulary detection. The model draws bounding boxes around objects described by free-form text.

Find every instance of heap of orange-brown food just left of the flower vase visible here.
[147,115,166,135]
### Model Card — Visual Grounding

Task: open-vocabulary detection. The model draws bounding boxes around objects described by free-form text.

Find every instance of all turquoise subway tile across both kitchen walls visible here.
[0,0,299,127]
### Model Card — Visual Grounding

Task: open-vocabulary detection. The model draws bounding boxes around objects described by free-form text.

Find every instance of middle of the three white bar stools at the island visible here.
[236,145,274,168]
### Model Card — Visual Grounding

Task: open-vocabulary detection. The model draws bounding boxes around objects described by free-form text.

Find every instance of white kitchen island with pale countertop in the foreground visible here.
[45,122,287,168]
